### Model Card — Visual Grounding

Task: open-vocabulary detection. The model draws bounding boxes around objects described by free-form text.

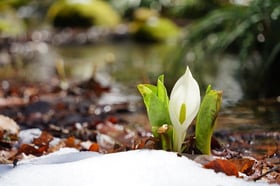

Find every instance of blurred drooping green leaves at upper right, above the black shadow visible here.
[187,0,280,59]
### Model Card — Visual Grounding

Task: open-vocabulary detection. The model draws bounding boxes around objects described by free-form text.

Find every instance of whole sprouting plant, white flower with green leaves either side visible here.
[138,67,221,154]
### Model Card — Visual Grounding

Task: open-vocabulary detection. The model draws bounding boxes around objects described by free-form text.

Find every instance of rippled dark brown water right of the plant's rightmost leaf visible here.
[219,99,280,133]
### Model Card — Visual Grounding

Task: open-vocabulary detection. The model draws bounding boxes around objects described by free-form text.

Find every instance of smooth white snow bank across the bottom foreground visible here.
[0,148,267,186]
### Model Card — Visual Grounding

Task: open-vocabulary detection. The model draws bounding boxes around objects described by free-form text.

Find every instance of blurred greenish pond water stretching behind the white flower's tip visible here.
[56,42,247,104]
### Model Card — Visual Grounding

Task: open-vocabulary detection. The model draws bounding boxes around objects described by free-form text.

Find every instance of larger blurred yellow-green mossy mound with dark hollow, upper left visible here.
[47,0,120,27]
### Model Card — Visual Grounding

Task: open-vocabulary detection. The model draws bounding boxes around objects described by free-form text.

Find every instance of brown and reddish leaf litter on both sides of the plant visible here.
[0,79,280,184]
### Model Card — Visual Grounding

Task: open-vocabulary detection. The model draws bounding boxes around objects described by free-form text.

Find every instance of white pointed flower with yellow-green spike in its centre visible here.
[169,67,200,152]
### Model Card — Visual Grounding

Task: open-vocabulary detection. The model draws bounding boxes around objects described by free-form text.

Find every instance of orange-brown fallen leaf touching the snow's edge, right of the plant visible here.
[204,159,238,177]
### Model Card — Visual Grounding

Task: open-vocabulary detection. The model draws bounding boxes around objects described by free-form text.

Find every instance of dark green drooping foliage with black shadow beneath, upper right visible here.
[185,0,280,96]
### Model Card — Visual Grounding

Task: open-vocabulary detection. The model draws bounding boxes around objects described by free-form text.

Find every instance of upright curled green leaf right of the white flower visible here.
[195,85,222,154]
